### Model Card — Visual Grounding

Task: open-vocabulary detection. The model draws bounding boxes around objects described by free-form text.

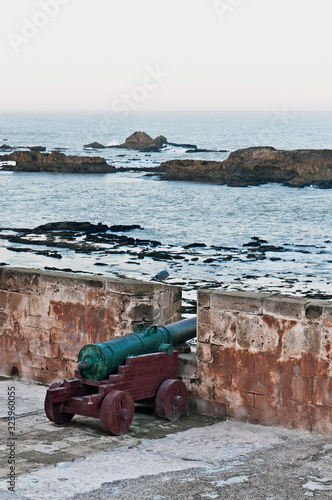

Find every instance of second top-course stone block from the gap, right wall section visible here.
[263,295,308,320]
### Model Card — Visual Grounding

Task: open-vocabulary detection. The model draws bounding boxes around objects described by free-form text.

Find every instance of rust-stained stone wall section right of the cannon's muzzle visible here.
[181,290,332,432]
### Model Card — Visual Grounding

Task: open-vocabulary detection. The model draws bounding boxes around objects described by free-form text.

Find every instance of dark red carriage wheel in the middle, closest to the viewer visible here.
[99,391,135,436]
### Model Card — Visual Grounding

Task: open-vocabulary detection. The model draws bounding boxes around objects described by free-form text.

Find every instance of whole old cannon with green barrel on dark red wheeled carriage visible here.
[44,316,197,435]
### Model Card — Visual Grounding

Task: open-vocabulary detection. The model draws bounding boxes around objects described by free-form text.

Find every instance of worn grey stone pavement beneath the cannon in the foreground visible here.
[0,378,332,500]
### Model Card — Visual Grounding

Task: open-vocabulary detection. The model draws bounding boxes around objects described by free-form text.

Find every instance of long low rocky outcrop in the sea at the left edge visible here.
[2,151,116,174]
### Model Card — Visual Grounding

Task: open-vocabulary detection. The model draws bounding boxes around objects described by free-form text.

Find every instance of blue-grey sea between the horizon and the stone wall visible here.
[0,109,332,310]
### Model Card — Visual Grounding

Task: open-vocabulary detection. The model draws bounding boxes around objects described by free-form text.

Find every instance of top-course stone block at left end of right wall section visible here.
[210,290,266,314]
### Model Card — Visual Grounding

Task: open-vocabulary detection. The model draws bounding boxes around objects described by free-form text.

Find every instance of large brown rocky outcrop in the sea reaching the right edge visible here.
[161,147,332,188]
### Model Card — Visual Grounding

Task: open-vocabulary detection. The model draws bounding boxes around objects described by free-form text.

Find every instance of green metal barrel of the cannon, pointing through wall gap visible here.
[77,316,197,380]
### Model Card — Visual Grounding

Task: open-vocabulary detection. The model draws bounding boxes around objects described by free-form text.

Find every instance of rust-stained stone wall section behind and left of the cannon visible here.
[0,268,181,382]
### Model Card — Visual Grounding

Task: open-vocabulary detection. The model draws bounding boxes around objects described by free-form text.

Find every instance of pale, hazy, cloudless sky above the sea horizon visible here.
[0,0,332,112]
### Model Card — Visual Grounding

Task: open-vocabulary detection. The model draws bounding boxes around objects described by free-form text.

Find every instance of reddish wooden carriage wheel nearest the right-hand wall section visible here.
[156,379,188,420]
